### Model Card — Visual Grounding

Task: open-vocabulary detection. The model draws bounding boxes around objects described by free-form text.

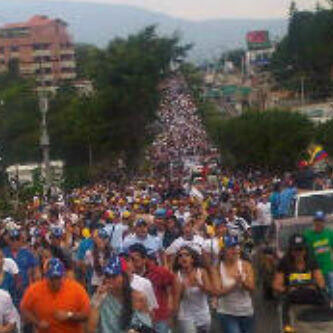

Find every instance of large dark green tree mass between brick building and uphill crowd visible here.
[50,26,190,175]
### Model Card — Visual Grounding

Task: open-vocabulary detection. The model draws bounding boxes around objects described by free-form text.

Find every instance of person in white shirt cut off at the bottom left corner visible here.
[0,289,21,333]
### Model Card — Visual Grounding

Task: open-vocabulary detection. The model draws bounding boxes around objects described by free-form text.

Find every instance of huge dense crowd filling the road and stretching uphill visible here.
[0,76,333,333]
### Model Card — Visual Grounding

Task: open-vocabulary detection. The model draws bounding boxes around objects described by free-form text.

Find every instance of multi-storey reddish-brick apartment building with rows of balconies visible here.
[0,15,76,87]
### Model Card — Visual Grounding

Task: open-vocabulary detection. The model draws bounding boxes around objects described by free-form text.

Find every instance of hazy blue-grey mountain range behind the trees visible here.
[0,0,287,61]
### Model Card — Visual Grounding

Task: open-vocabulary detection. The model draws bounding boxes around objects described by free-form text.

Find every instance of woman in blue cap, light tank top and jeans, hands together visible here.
[213,235,255,333]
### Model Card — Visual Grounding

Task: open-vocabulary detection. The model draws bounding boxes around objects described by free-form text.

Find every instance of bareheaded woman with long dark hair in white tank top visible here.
[174,246,213,333]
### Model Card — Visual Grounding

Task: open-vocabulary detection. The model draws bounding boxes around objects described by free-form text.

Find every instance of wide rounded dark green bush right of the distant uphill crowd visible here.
[218,110,314,170]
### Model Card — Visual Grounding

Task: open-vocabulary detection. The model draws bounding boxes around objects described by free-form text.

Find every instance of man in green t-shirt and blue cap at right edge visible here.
[304,211,333,308]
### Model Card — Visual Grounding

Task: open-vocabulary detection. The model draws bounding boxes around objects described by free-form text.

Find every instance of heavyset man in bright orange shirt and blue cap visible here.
[21,258,90,333]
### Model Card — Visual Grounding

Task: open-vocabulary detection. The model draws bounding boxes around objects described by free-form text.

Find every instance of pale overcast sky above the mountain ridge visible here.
[46,0,325,20]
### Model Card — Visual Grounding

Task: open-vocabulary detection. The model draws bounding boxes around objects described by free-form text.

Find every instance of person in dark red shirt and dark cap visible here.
[129,243,178,333]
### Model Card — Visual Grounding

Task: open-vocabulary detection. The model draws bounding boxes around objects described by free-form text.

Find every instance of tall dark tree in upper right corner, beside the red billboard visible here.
[271,10,333,99]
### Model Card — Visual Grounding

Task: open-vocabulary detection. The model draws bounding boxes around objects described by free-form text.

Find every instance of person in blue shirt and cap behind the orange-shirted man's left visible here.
[3,229,40,301]
